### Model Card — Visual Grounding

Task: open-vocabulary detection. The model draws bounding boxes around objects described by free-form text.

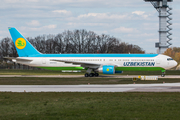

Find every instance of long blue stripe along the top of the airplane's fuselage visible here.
[29,54,158,57]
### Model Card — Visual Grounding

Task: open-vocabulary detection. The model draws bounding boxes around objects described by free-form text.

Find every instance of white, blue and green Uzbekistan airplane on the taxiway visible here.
[6,27,177,77]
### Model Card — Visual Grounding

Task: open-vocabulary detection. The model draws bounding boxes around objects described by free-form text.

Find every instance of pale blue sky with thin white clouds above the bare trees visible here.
[0,0,180,53]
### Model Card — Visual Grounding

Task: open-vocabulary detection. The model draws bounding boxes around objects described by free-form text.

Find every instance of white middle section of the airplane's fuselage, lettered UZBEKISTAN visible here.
[13,55,177,69]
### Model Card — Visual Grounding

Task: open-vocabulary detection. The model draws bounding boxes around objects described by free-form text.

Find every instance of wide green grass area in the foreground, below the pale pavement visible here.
[0,93,180,120]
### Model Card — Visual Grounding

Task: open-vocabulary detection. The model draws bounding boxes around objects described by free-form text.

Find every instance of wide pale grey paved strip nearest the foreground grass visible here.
[0,83,180,92]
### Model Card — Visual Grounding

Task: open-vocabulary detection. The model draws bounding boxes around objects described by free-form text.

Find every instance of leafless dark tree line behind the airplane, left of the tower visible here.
[0,29,145,60]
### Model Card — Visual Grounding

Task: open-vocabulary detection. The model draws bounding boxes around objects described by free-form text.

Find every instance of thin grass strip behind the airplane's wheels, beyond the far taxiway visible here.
[0,69,180,75]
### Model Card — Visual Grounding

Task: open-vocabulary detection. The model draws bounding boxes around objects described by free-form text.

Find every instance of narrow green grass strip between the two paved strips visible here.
[0,77,180,85]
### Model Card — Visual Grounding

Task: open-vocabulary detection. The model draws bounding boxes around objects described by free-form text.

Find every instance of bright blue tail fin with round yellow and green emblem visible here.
[9,27,41,57]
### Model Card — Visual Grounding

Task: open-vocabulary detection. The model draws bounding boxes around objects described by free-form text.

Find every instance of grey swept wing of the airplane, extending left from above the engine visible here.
[50,59,101,69]
